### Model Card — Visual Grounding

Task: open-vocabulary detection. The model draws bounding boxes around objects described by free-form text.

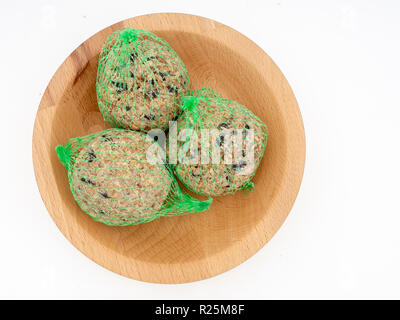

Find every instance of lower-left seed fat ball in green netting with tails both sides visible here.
[56,129,212,226]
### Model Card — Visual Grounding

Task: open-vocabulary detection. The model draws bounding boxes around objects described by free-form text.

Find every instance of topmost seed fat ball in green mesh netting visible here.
[96,28,190,131]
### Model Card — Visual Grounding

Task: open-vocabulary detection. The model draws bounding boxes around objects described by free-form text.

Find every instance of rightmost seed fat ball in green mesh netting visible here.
[169,88,268,196]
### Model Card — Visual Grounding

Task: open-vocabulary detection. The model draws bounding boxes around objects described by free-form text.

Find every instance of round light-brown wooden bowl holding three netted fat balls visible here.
[33,13,305,283]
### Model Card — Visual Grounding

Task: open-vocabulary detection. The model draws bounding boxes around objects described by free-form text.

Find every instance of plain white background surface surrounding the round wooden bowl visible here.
[0,0,400,299]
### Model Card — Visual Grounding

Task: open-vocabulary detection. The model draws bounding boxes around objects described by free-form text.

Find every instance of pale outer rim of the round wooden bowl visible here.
[32,13,305,283]
